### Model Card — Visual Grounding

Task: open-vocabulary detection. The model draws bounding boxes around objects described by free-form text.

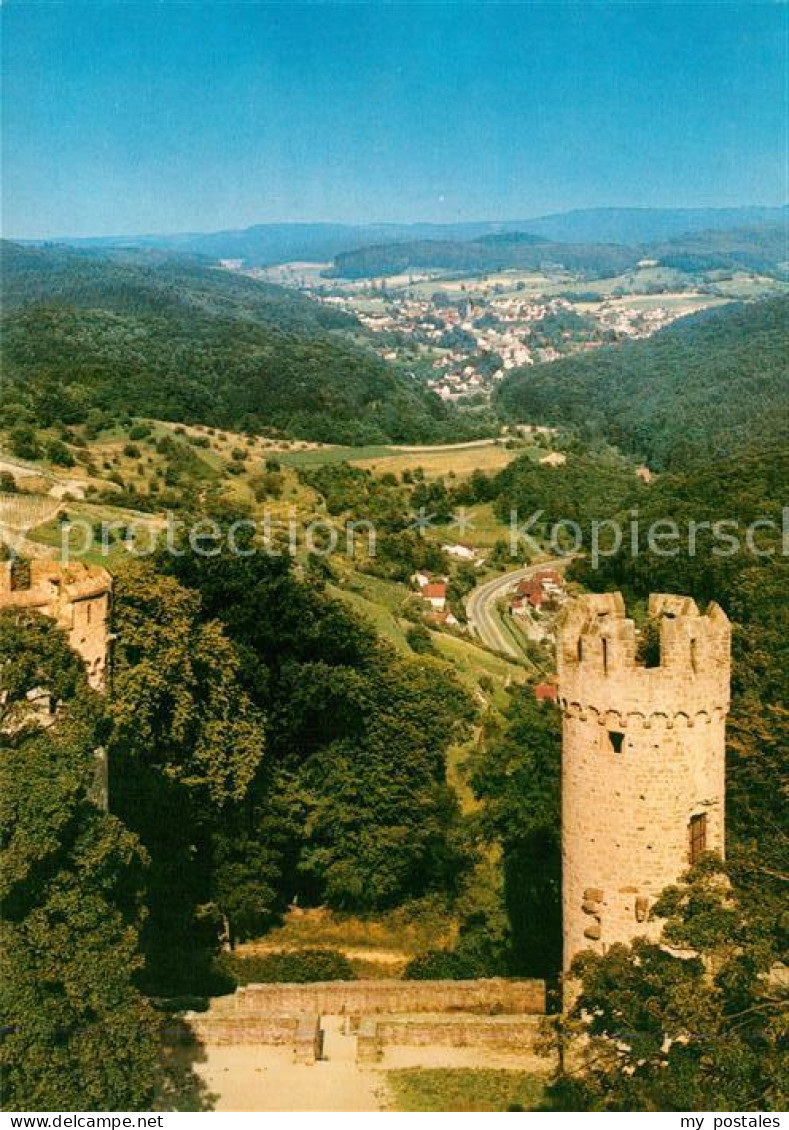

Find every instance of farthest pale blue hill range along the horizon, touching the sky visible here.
[26,207,788,266]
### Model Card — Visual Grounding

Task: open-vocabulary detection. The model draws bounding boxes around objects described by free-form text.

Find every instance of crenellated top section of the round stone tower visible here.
[557,592,731,719]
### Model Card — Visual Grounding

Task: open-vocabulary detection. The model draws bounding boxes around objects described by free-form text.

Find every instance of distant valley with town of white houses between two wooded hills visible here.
[244,236,789,403]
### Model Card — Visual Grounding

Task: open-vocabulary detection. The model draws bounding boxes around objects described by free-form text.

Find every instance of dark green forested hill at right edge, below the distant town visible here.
[497,297,789,470]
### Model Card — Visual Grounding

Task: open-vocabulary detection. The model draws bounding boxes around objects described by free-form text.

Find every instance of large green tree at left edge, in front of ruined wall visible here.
[0,612,159,1111]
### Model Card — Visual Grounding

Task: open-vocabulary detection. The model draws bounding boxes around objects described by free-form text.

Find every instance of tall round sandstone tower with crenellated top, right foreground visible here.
[557,592,731,971]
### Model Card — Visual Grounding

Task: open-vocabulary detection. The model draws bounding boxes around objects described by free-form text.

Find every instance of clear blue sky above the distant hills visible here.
[0,0,789,237]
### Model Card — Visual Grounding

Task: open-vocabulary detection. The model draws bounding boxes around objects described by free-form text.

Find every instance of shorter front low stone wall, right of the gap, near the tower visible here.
[356,1015,539,1063]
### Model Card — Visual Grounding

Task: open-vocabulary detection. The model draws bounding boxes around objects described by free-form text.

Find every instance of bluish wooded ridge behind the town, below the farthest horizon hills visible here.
[331,224,789,279]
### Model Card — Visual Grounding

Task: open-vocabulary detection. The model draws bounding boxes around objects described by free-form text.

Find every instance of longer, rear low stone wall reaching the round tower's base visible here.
[221,977,545,1016]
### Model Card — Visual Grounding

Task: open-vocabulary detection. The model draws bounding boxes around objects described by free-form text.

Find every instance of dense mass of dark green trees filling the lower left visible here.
[0,535,476,1110]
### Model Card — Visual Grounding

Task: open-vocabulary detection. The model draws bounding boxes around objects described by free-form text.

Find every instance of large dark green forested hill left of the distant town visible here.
[2,244,480,443]
